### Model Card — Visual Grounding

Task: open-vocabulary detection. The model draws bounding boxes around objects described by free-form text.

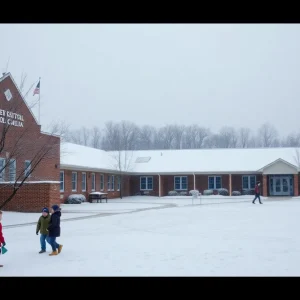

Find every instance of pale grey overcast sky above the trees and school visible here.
[0,24,300,134]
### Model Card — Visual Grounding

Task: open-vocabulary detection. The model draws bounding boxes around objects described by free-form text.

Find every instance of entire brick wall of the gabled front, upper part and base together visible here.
[0,77,60,211]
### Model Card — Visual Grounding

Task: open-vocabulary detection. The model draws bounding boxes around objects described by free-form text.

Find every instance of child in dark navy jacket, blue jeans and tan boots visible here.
[47,204,63,256]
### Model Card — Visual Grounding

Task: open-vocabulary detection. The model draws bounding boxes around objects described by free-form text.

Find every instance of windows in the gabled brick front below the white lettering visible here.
[0,158,31,182]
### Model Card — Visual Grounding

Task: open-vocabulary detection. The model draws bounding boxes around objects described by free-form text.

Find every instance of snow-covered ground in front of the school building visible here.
[0,197,300,276]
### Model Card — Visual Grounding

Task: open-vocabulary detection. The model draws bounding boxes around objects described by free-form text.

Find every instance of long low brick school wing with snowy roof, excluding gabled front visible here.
[60,143,300,201]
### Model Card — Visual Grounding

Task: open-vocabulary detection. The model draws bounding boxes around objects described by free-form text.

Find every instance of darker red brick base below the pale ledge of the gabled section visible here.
[0,183,60,212]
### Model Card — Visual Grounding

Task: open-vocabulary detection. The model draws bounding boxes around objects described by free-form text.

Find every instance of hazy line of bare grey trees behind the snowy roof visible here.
[63,121,300,151]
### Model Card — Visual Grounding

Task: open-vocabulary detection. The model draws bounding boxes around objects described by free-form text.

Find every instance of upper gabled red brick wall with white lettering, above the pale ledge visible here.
[0,77,60,181]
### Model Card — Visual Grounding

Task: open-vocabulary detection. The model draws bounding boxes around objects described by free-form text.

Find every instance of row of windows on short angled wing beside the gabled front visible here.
[60,171,121,192]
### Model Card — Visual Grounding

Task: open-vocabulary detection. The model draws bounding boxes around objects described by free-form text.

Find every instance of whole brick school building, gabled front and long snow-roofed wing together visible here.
[0,73,300,212]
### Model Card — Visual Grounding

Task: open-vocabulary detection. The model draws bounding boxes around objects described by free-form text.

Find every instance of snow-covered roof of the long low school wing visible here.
[61,143,300,174]
